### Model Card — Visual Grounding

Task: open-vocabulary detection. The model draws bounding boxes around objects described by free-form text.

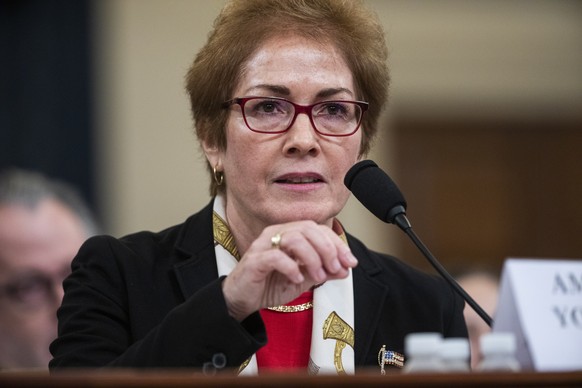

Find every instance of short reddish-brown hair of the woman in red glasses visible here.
[186,0,389,195]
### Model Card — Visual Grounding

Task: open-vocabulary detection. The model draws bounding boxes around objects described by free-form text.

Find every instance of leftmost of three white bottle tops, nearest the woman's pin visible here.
[403,333,443,373]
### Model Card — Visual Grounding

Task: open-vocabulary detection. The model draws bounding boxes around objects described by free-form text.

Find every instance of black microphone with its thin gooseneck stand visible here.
[344,160,493,327]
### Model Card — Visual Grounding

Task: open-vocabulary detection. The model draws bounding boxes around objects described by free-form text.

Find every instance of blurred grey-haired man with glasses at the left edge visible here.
[0,169,97,369]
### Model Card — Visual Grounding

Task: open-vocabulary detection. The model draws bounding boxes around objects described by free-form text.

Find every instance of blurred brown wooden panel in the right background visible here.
[393,119,582,270]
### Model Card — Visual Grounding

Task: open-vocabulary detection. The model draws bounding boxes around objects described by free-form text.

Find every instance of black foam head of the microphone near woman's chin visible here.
[344,160,406,223]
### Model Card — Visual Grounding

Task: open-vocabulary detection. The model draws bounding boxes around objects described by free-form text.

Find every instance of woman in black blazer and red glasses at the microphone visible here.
[50,0,466,374]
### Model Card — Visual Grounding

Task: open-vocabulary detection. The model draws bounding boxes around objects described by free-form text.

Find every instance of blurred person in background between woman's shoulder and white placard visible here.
[457,270,499,370]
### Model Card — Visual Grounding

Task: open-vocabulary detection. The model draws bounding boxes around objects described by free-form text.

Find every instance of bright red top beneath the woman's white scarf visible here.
[257,290,313,371]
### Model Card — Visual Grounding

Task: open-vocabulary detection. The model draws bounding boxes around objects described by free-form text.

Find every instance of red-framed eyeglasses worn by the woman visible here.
[224,97,368,136]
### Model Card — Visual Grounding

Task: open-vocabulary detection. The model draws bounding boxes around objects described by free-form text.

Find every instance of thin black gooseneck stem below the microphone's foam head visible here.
[389,211,493,327]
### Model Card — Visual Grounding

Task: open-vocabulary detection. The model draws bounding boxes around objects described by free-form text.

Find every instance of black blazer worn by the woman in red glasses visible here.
[50,203,467,369]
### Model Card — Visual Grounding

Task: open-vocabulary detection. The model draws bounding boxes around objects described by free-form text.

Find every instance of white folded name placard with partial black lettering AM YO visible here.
[493,258,582,371]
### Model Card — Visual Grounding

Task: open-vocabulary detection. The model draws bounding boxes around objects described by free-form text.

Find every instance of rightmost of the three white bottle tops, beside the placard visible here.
[477,333,521,372]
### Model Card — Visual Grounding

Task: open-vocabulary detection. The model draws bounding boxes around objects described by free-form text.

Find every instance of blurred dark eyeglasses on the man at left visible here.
[0,268,71,308]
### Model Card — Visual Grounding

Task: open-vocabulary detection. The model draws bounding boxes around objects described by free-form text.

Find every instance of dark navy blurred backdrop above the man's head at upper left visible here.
[0,0,96,206]
